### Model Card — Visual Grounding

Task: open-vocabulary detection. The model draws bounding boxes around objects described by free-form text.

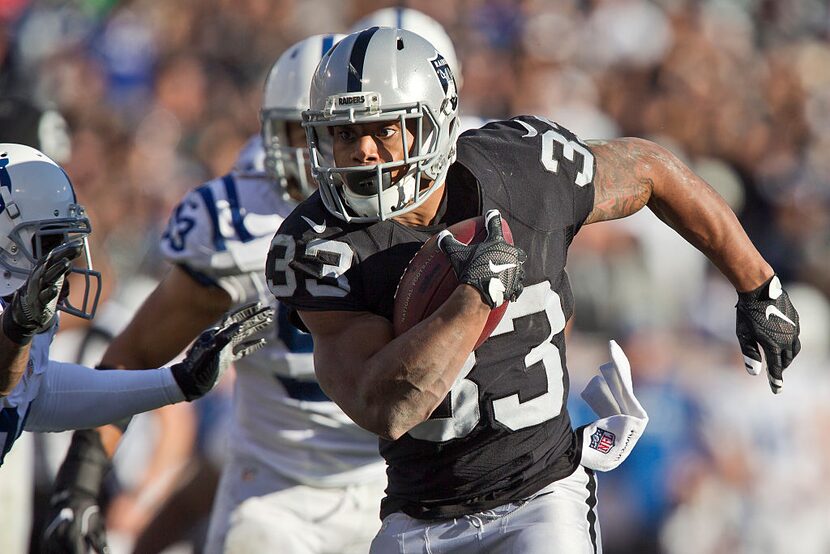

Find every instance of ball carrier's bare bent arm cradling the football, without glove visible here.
[300,285,490,440]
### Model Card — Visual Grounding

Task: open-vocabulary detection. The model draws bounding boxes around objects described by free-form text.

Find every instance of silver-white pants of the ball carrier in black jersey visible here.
[370,466,602,554]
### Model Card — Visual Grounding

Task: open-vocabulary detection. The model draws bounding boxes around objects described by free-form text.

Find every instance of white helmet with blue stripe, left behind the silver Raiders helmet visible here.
[260,34,345,198]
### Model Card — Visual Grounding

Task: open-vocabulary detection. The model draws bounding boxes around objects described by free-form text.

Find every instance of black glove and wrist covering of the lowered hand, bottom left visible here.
[41,429,109,554]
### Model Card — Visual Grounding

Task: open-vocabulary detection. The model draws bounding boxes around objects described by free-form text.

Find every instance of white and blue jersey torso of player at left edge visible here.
[0,300,58,464]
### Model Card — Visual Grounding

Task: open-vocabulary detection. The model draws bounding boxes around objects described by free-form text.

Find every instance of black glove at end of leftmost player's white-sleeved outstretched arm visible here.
[170,302,274,401]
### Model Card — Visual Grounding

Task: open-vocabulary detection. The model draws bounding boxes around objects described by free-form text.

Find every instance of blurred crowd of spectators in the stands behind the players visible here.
[0,0,830,554]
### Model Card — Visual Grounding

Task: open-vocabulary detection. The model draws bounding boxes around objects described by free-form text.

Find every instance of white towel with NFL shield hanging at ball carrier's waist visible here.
[577,340,648,471]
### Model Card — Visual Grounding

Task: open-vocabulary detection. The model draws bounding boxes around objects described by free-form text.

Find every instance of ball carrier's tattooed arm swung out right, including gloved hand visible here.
[586,138,801,393]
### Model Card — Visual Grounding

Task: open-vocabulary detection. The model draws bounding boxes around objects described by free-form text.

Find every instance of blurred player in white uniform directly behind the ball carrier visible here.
[42,35,386,553]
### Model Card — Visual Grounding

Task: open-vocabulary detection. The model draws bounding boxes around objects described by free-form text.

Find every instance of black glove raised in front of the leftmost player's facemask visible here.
[3,239,84,344]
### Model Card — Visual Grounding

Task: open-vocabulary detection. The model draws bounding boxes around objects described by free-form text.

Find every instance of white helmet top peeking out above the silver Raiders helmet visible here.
[349,8,462,90]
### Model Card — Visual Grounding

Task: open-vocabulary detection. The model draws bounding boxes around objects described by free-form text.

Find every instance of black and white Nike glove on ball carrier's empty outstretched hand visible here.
[735,275,801,394]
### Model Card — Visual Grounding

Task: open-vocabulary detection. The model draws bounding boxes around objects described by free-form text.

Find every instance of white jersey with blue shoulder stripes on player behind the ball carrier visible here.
[161,139,384,487]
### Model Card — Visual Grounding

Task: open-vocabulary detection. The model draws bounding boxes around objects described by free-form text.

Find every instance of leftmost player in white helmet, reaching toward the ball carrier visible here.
[0,143,271,464]
